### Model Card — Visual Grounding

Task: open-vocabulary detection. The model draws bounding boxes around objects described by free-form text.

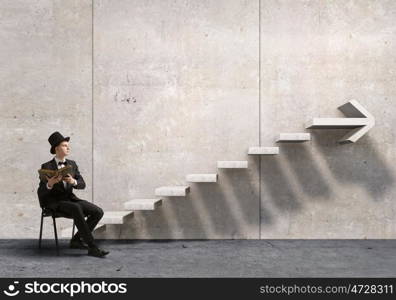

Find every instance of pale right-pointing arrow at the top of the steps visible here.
[306,100,375,144]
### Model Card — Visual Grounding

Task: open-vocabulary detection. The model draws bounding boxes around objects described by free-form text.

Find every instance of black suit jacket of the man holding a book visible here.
[37,158,85,209]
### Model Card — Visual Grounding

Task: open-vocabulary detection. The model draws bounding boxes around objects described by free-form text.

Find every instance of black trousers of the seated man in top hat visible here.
[54,199,103,246]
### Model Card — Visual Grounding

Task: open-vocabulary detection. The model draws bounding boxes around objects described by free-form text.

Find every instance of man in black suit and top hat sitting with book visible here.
[37,131,109,257]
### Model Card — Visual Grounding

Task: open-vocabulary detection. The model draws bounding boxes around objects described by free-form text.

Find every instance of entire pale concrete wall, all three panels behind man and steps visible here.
[0,0,396,239]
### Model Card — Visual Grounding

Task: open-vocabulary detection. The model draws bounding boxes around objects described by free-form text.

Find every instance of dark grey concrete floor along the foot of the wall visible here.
[0,239,396,277]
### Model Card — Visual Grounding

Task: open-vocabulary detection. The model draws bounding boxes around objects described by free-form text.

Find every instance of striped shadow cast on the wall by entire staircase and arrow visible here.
[101,130,394,239]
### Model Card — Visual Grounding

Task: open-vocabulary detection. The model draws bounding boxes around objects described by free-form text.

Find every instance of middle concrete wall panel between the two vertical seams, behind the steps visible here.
[94,0,259,238]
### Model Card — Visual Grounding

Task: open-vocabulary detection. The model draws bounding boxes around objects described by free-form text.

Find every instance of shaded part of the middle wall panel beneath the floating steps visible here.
[109,162,262,239]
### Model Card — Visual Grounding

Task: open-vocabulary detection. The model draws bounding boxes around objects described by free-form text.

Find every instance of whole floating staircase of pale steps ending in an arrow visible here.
[61,100,375,238]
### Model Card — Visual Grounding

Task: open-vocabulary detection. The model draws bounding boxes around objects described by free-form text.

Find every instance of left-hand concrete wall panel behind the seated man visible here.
[0,0,92,238]
